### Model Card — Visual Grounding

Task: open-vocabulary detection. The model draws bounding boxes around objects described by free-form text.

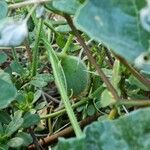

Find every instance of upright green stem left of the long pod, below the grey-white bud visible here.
[31,19,43,77]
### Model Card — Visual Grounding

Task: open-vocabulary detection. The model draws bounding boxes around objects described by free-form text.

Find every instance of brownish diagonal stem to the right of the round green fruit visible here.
[64,15,120,100]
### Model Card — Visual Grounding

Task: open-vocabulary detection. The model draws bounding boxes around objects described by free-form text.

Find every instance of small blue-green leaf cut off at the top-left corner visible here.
[0,0,8,19]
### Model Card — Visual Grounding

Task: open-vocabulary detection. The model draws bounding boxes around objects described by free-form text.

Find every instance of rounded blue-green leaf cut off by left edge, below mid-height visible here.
[0,79,17,109]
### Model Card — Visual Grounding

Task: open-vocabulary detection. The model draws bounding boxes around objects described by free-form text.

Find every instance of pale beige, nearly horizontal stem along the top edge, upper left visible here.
[8,0,52,9]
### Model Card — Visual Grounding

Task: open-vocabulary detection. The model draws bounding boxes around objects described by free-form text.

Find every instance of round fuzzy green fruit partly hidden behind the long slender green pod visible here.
[59,55,89,96]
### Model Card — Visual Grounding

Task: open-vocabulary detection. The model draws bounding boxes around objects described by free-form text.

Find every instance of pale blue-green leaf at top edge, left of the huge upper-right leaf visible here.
[52,0,80,15]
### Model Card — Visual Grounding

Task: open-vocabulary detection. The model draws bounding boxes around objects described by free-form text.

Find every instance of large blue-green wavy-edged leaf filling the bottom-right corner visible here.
[56,108,150,150]
